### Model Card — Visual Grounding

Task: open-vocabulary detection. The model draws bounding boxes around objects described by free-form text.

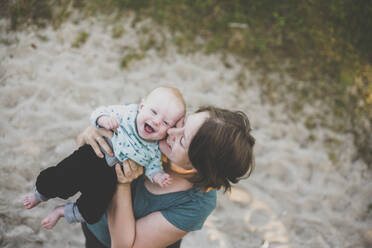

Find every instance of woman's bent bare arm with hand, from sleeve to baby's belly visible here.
[108,163,187,248]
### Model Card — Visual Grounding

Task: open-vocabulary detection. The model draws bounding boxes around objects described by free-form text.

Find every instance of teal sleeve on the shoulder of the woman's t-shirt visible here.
[161,190,216,232]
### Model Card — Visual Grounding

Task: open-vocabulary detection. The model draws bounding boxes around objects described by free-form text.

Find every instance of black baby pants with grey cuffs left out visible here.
[36,145,117,224]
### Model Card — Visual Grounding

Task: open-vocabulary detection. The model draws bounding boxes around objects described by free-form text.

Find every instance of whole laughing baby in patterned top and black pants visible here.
[23,87,186,229]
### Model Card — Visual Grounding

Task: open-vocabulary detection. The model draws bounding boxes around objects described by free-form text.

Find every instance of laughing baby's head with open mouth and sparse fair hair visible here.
[136,91,185,141]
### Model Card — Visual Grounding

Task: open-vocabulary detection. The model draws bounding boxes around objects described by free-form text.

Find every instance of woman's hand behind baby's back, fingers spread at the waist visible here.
[76,126,113,158]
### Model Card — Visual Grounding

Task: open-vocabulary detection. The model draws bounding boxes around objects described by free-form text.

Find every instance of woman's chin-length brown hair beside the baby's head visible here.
[189,106,255,192]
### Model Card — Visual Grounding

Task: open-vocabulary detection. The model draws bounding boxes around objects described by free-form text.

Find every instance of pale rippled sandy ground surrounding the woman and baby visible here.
[0,15,372,248]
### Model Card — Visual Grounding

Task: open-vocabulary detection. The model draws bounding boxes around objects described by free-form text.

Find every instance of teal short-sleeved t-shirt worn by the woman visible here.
[88,176,216,247]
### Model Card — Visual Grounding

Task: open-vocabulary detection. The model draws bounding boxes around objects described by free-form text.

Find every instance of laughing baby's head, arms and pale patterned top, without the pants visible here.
[91,87,186,187]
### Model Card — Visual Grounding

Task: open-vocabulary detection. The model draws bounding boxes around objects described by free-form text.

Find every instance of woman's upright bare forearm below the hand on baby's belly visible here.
[108,183,136,248]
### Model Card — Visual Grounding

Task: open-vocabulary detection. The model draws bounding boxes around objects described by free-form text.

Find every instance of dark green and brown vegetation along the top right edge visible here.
[0,0,372,165]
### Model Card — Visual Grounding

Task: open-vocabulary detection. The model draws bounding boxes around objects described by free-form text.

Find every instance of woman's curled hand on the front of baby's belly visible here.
[115,159,143,184]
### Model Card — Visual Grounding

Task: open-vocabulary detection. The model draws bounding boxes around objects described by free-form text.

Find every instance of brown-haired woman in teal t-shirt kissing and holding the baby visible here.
[78,107,255,248]
